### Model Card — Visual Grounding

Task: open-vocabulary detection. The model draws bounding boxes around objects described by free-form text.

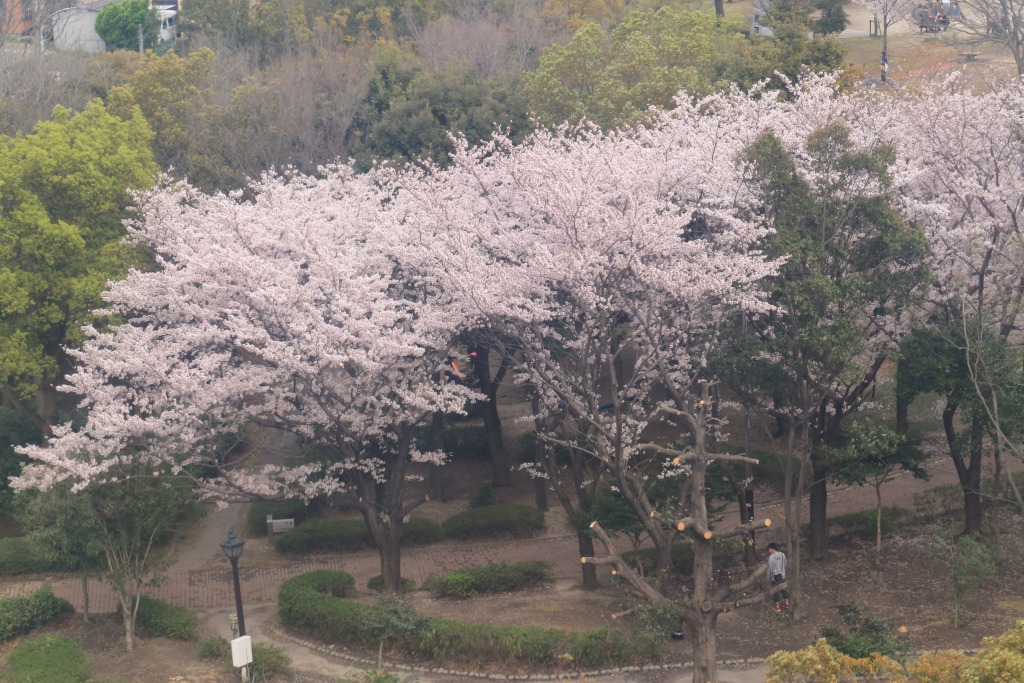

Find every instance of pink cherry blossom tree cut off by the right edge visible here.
[880,80,1024,532]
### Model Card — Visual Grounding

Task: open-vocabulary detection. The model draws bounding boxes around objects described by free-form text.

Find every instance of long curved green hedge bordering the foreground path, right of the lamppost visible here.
[278,571,664,669]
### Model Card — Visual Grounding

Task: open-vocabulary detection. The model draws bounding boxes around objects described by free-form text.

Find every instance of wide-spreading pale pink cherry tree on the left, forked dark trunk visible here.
[18,167,474,591]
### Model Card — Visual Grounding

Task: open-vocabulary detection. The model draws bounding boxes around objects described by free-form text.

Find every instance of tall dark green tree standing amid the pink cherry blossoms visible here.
[718,124,929,610]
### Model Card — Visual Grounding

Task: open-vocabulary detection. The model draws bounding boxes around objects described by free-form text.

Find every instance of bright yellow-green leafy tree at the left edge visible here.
[0,100,157,438]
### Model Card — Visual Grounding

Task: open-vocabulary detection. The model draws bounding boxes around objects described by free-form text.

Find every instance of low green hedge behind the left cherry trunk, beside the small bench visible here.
[273,517,444,554]
